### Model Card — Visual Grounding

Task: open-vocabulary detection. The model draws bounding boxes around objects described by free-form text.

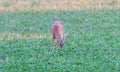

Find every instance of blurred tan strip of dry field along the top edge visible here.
[0,0,120,12]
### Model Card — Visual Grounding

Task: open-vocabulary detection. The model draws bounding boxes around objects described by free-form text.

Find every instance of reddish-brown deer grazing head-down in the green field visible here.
[51,21,66,48]
